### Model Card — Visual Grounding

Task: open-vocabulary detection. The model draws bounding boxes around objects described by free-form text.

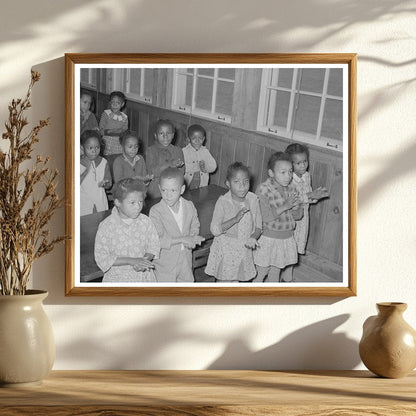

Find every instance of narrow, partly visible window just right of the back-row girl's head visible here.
[123,68,154,104]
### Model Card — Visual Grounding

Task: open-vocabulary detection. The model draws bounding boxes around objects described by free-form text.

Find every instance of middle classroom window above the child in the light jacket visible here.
[172,68,235,123]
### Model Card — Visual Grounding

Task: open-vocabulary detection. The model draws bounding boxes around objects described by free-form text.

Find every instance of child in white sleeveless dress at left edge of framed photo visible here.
[80,130,111,215]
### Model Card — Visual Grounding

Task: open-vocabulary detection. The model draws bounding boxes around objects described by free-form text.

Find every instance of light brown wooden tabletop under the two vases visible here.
[0,370,416,416]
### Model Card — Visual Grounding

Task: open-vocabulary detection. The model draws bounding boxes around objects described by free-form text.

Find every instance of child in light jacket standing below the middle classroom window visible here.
[183,124,217,189]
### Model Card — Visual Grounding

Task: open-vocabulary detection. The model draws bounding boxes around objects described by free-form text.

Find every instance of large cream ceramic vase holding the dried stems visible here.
[0,290,55,387]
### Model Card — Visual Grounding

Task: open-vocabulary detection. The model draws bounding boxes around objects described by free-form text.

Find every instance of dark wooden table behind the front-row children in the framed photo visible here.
[80,185,227,282]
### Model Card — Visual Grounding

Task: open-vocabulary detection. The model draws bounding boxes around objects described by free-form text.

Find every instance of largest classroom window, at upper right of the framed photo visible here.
[257,68,344,150]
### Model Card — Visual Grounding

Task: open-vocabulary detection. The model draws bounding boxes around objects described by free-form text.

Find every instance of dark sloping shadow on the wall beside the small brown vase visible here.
[207,314,361,370]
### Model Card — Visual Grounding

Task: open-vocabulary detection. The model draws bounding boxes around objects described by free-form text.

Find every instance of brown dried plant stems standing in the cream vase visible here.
[0,71,66,295]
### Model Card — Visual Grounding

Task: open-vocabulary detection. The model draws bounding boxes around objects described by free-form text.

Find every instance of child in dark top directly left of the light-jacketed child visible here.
[146,120,185,198]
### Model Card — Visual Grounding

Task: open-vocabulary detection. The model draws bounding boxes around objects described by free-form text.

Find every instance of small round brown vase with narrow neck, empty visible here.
[359,302,416,378]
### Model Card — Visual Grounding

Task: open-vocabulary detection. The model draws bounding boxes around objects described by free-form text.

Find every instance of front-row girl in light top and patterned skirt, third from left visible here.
[205,162,262,282]
